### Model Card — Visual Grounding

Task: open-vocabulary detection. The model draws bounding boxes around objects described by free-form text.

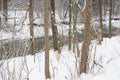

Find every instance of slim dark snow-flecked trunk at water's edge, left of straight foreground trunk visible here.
[29,0,34,55]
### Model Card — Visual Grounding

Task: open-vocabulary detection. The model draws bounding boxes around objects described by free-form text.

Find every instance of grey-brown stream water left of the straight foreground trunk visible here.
[0,37,44,59]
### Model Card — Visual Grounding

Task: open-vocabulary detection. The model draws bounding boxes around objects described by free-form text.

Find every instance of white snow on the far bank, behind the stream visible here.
[0,10,120,40]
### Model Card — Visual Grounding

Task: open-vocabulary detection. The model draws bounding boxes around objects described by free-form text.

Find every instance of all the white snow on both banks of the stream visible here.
[0,12,120,80]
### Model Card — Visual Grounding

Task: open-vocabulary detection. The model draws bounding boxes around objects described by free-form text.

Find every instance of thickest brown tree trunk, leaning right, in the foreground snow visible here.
[80,0,92,73]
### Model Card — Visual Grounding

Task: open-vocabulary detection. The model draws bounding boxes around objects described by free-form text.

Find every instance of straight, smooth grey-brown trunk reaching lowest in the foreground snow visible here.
[44,0,50,79]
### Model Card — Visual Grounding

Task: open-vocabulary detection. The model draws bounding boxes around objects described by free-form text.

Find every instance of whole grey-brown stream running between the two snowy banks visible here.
[0,27,117,60]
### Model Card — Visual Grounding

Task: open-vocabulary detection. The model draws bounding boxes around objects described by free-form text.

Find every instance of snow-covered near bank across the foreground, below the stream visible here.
[0,36,120,80]
